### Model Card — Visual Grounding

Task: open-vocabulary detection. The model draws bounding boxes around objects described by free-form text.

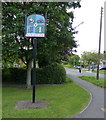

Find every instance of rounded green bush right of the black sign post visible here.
[37,63,66,84]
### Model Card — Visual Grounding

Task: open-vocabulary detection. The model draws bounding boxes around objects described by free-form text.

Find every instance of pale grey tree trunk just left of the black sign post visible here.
[26,62,32,88]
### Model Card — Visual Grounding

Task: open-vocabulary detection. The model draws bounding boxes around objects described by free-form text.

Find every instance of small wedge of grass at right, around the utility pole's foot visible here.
[79,76,106,88]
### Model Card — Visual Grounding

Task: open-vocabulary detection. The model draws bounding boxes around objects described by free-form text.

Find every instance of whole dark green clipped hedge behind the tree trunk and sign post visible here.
[2,63,66,84]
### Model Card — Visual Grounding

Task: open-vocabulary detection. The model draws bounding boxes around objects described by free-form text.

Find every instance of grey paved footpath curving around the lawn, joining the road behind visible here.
[65,68,106,118]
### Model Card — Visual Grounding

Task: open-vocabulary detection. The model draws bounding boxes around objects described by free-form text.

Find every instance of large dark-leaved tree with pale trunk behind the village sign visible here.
[2,2,80,86]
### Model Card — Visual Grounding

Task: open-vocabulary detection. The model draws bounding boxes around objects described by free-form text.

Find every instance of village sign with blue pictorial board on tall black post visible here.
[25,14,45,103]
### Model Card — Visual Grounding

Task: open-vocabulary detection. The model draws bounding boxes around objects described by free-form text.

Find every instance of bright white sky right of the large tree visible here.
[70,0,106,56]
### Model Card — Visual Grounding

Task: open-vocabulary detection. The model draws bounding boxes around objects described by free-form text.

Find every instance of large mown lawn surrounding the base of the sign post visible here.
[2,78,90,118]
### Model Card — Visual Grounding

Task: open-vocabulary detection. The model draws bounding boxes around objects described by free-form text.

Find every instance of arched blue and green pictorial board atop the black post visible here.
[25,14,45,37]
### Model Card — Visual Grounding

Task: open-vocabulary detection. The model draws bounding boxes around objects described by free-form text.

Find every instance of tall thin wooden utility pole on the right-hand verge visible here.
[96,7,103,80]
